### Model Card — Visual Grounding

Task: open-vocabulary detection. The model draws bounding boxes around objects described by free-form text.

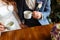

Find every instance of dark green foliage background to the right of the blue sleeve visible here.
[47,0,60,23]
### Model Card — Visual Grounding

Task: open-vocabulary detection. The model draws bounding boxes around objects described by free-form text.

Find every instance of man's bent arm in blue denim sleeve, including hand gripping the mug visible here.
[33,0,51,20]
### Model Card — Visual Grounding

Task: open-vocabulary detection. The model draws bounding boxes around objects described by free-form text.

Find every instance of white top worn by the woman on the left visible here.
[0,5,20,30]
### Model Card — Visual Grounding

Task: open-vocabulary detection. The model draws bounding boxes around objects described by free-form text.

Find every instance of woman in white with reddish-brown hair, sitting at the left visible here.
[0,0,20,31]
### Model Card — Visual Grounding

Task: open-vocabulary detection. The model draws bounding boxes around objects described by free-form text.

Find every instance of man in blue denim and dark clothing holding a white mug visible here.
[15,0,51,27]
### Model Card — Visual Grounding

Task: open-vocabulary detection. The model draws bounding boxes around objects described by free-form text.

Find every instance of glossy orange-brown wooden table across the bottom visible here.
[0,24,53,40]
